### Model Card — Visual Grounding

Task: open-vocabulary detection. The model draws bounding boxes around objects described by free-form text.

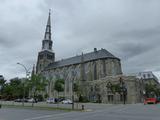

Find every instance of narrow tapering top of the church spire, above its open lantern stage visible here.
[44,9,51,40]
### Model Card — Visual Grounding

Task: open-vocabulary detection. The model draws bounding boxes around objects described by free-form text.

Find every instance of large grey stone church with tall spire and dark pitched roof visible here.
[36,13,142,103]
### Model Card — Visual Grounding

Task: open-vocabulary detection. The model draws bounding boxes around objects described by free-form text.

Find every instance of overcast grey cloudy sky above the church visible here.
[0,0,160,79]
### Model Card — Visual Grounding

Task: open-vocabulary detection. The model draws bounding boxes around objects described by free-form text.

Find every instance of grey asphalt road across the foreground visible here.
[0,104,160,120]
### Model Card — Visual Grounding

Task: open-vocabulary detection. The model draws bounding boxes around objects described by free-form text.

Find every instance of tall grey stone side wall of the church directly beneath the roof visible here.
[43,58,122,98]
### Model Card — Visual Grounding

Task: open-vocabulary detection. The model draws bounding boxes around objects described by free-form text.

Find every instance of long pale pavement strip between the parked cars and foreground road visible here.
[0,101,131,111]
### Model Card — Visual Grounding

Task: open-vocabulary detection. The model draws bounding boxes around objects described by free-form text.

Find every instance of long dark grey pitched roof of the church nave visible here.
[46,49,120,69]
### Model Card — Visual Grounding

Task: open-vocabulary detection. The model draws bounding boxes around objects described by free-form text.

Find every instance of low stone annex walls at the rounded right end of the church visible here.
[85,75,144,103]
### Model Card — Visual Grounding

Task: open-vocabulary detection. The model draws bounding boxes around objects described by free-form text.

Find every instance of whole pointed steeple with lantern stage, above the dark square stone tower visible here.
[42,10,52,51]
